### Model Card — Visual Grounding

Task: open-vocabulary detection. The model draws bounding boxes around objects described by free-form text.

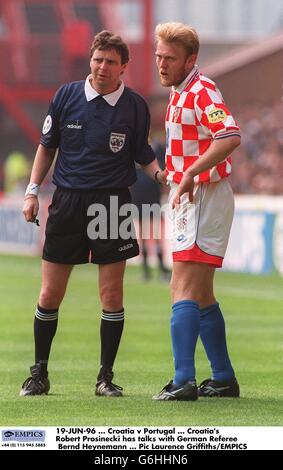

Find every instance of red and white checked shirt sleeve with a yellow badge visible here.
[195,87,240,140]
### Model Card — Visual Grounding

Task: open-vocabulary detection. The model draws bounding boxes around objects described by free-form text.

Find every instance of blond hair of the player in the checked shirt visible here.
[155,22,199,55]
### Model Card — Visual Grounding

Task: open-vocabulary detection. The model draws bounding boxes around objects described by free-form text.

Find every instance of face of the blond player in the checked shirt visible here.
[155,41,196,86]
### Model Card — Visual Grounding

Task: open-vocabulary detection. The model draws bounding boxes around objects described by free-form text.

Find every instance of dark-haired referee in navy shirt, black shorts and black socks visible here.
[20,31,163,397]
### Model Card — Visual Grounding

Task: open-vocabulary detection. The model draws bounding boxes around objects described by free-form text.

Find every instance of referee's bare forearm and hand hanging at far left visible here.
[23,144,56,222]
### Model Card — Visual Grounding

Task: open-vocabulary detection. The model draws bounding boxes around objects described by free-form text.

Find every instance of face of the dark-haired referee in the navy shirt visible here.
[90,49,127,95]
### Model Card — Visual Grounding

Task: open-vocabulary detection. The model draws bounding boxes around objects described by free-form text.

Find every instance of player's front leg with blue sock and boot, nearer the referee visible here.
[154,261,215,400]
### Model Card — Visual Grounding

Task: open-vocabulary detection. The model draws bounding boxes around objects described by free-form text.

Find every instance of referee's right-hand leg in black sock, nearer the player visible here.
[96,261,126,396]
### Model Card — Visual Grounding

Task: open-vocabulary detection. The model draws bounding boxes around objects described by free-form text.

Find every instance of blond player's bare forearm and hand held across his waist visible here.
[172,136,241,208]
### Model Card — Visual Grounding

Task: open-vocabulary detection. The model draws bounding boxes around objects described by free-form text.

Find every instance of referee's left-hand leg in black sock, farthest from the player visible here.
[20,260,73,396]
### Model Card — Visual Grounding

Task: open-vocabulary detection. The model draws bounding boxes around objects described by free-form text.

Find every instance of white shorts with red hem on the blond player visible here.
[168,179,234,267]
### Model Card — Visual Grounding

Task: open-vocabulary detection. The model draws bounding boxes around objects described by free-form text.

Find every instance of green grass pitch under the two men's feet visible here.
[0,256,283,426]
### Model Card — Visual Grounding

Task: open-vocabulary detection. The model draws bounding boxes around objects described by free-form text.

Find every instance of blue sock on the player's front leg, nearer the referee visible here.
[171,300,200,385]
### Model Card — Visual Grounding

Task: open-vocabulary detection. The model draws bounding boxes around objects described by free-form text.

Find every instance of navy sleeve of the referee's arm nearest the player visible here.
[134,95,155,165]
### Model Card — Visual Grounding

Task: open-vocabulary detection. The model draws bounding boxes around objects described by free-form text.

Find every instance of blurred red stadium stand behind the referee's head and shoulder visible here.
[0,0,152,161]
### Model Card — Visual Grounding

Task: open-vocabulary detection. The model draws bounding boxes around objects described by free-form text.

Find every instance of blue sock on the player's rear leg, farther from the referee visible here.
[200,303,235,382]
